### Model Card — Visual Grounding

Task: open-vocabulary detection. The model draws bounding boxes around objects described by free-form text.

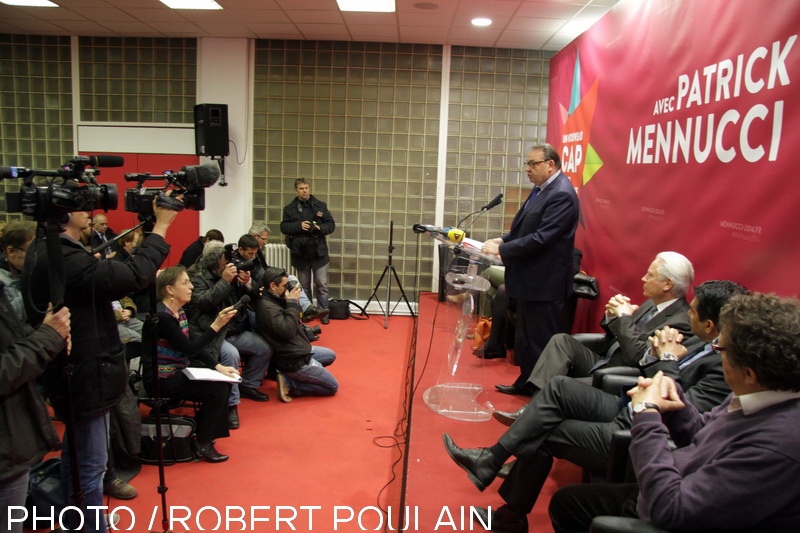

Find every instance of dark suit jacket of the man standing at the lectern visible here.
[500,171,579,302]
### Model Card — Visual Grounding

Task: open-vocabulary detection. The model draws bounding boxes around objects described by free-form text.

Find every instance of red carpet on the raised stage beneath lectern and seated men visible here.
[405,294,580,533]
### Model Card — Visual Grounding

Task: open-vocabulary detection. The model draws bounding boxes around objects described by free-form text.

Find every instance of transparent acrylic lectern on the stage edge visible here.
[422,236,501,422]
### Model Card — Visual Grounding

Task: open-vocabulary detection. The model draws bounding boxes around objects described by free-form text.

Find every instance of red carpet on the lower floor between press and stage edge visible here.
[36,316,413,533]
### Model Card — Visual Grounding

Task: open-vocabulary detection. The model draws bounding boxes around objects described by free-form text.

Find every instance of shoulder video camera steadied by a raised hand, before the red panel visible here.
[125,163,220,215]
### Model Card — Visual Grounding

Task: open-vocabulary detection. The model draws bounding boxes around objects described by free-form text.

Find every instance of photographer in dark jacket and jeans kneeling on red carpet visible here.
[256,267,339,402]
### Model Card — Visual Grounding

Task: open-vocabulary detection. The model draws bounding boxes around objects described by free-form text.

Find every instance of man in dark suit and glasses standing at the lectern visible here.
[481,144,580,396]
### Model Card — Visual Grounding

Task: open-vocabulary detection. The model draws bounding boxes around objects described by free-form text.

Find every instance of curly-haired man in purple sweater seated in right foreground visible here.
[550,294,800,533]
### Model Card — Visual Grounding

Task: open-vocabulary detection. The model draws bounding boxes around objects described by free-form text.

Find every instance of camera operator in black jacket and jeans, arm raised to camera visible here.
[29,200,177,532]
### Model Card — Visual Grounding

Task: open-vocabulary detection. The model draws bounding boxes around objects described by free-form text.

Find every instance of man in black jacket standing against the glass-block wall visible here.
[281,178,336,324]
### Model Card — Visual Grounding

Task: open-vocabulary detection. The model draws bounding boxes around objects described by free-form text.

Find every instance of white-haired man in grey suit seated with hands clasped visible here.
[498,252,694,402]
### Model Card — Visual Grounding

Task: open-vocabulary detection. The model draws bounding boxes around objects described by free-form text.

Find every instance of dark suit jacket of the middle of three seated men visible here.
[641,337,731,413]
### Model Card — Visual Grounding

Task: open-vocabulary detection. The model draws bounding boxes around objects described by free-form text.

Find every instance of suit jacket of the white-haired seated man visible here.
[600,298,692,366]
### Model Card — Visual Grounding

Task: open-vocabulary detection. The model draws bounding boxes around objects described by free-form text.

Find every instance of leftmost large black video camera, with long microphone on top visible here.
[0,155,125,222]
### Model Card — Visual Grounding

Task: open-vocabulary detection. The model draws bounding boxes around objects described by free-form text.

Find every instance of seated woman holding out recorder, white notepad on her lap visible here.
[142,266,239,463]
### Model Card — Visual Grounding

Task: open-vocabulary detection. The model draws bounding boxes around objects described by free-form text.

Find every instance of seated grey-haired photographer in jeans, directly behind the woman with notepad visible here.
[189,242,272,429]
